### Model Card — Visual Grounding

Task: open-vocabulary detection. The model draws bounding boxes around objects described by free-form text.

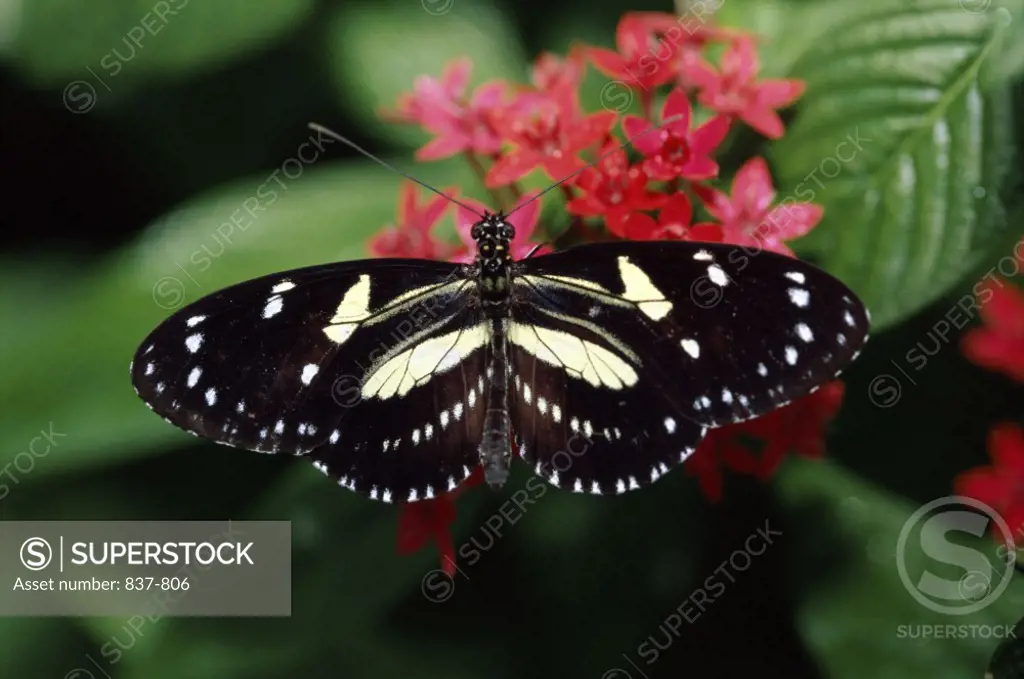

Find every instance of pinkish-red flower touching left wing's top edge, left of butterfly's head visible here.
[370,181,458,259]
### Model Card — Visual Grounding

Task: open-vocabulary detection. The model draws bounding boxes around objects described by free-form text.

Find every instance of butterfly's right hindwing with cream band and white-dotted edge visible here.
[509,300,705,495]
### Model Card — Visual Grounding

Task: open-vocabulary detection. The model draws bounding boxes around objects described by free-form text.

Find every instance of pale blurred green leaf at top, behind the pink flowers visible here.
[330,0,527,145]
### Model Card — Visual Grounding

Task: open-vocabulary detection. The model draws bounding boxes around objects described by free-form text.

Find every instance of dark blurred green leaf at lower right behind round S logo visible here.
[776,460,1024,679]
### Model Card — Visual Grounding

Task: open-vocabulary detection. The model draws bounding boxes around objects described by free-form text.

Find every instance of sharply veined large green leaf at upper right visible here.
[772,0,1013,329]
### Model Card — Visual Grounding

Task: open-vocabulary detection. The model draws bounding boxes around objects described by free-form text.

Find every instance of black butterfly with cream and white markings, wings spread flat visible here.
[125,213,868,502]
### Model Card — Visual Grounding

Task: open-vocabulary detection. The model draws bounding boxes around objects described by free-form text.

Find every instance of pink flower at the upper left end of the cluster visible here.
[385,58,505,161]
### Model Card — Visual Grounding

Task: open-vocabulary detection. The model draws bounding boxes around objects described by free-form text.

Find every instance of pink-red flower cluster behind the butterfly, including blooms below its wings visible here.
[371,12,831,568]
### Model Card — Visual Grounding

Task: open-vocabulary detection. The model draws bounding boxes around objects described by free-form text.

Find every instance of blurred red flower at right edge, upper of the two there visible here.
[963,274,1024,382]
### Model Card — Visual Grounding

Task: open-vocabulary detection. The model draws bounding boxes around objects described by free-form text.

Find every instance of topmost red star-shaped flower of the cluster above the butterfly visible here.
[587,12,679,92]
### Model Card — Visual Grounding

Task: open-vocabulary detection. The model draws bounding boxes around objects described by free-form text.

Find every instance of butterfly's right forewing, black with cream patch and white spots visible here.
[513,242,868,426]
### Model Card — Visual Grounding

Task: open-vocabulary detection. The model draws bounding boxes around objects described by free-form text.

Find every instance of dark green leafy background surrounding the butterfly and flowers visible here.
[0,0,1024,679]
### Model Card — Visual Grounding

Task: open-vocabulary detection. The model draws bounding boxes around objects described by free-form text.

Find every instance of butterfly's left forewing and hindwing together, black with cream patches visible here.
[131,260,488,501]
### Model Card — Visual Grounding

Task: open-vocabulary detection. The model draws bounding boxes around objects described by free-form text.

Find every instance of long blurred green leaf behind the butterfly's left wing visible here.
[0,160,472,481]
